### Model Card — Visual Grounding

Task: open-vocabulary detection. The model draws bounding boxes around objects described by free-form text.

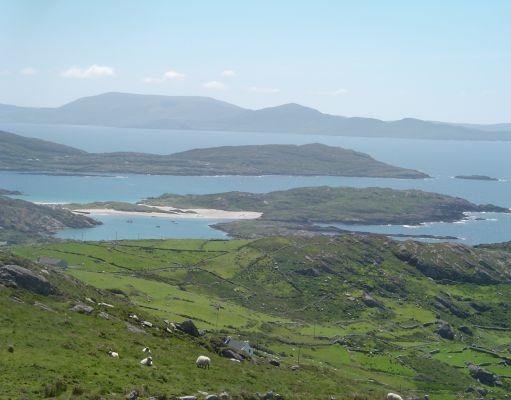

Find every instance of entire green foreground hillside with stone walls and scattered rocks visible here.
[0,235,511,400]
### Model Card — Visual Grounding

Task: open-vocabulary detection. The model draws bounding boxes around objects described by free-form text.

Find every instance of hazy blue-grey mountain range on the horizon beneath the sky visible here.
[0,93,511,140]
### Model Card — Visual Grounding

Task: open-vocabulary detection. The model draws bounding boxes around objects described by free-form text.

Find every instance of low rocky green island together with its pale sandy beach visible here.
[63,186,510,239]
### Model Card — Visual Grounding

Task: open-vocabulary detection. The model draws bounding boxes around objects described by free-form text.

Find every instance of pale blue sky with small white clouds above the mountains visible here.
[0,0,511,123]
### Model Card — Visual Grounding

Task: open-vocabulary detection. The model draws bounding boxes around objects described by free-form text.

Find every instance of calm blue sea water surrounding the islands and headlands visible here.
[0,124,511,243]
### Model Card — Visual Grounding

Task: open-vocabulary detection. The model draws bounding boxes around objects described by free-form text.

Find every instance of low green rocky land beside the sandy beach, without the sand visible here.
[143,186,508,237]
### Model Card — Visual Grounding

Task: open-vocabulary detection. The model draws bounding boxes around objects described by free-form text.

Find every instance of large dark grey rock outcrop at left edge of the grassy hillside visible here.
[0,265,55,296]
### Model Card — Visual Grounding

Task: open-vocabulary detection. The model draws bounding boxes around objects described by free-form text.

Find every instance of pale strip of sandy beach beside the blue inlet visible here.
[73,204,262,220]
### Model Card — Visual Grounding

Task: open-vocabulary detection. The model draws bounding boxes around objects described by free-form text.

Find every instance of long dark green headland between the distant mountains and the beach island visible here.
[0,132,428,179]
